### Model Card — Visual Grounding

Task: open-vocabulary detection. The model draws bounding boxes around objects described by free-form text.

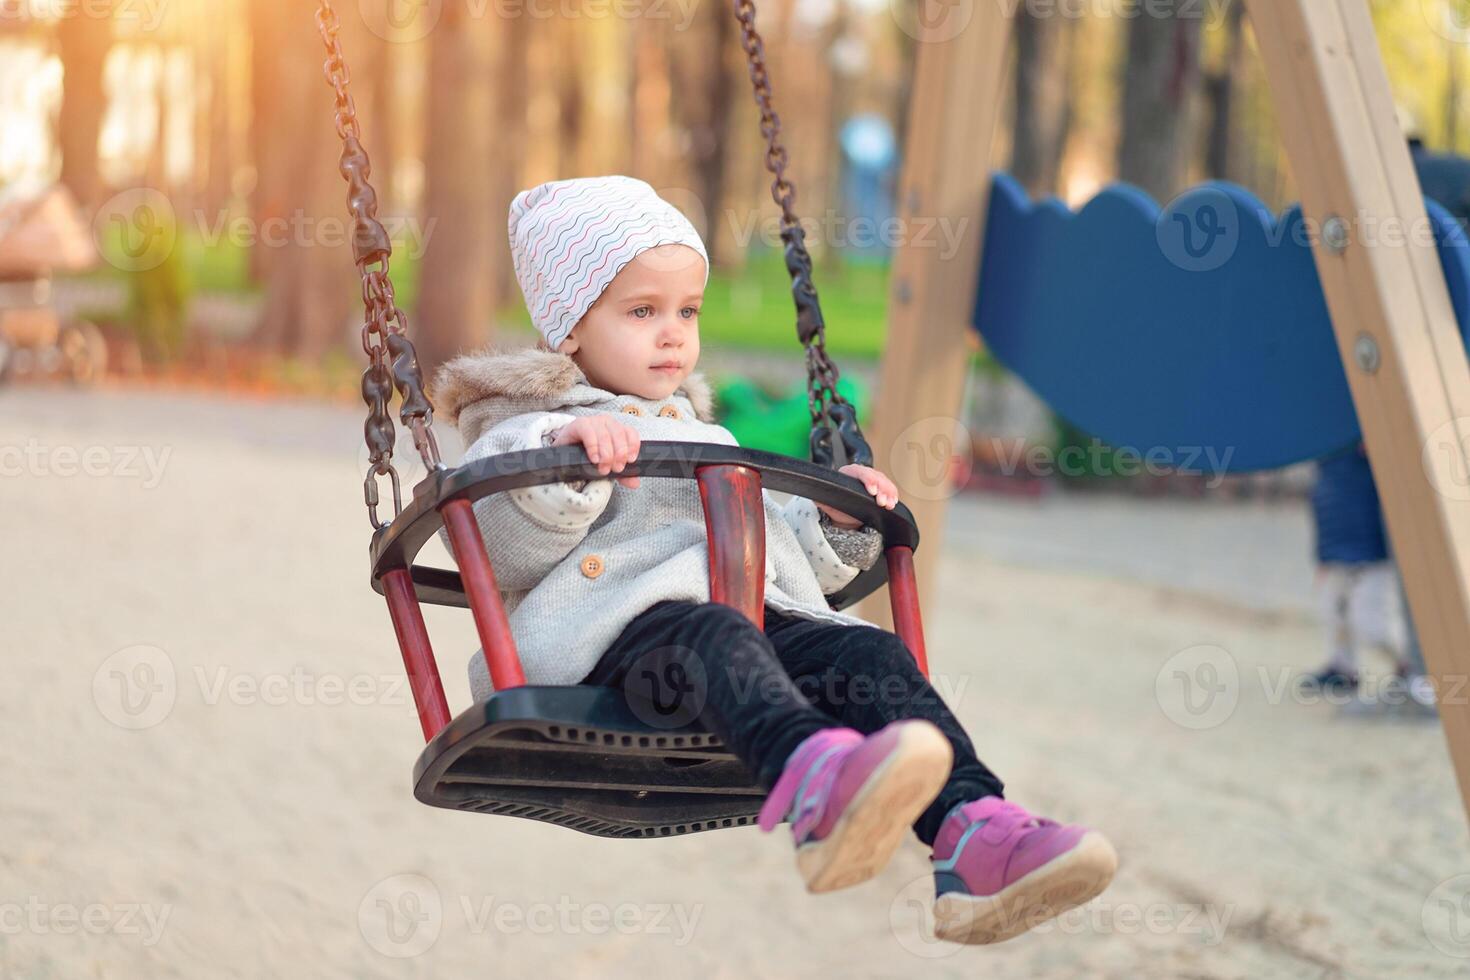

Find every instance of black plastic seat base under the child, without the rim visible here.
[413,686,766,837]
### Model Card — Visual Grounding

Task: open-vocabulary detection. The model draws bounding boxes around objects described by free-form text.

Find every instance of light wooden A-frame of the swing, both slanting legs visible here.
[887,0,1470,828]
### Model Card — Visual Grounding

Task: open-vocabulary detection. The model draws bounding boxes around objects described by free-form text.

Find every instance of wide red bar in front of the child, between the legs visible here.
[694,463,766,629]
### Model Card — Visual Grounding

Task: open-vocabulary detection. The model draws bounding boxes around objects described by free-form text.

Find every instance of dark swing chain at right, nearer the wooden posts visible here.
[734,0,873,469]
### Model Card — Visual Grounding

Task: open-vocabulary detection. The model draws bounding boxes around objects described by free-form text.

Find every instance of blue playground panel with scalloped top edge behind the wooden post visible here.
[973,173,1470,472]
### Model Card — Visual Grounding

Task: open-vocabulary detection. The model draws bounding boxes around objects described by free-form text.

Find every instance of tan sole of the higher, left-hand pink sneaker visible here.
[797,721,954,892]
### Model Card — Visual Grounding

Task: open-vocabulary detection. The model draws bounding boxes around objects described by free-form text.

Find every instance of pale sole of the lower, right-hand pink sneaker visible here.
[933,830,1117,946]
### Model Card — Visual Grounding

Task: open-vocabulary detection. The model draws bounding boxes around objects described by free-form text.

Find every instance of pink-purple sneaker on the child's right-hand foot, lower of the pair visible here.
[933,796,1117,945]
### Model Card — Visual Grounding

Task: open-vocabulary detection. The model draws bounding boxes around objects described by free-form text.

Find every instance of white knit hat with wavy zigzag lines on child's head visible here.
[510,175,710,350]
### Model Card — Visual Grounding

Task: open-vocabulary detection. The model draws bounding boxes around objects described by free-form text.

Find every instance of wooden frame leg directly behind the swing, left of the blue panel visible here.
[857,0,1016,629]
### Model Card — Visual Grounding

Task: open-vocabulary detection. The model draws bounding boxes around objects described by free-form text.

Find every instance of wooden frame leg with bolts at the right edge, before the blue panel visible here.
[1247,0,1470,828]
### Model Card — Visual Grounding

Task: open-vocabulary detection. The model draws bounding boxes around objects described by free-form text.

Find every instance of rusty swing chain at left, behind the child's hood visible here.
[316,0,444,529]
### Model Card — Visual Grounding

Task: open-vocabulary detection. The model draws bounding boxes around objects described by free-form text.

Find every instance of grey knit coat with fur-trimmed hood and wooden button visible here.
[434,348,882,701]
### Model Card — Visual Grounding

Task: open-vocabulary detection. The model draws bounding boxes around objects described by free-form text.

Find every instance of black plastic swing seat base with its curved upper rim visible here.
[385,441,919,837]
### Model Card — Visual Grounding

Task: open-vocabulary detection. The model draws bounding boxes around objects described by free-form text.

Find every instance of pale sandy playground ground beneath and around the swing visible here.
[0,389,1470,979]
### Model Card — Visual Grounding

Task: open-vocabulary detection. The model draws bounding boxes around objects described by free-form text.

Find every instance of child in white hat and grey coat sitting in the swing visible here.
[435,176,1117,943]
